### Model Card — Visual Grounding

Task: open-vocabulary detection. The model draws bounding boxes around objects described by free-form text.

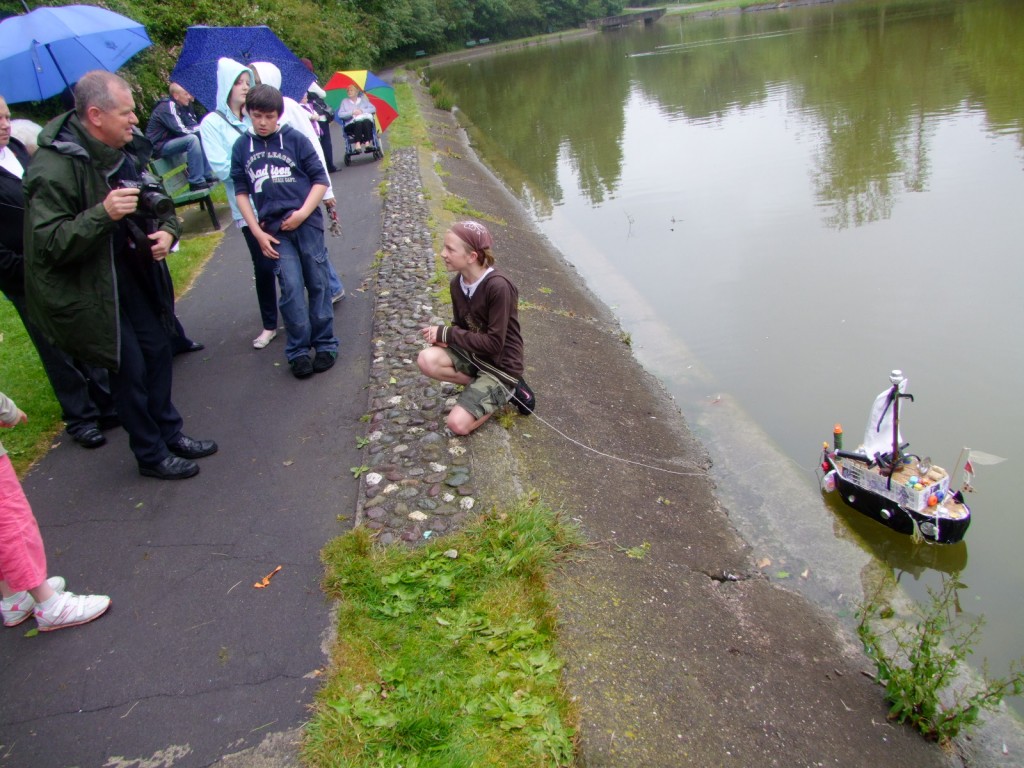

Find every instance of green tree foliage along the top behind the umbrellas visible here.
[0,0,623,121]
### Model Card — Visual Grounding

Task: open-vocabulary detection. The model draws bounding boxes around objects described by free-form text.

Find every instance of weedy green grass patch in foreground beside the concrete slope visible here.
[303,499,580,768]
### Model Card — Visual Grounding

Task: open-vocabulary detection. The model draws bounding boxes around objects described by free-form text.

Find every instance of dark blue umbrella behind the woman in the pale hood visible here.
[171,27,313,111]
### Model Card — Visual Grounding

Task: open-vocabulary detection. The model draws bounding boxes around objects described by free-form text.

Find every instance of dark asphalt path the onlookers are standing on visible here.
[0,136,383,768]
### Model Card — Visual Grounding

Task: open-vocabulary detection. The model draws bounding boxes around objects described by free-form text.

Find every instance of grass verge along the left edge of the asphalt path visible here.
[0,225,223,475]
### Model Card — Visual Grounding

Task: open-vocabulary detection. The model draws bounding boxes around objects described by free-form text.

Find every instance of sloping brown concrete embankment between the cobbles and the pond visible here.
[395,73,962,766]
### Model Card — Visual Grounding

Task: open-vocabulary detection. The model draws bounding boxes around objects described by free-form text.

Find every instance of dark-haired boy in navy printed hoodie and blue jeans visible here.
[231,85,338,379]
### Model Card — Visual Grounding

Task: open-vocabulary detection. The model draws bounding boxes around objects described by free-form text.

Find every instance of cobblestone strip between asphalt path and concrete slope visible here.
[355,148,474,544]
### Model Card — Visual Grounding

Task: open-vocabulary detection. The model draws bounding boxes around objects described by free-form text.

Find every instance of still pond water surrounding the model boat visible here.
[431,0,1024,712]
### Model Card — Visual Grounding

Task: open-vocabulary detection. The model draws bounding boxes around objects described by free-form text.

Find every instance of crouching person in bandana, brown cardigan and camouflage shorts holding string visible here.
[417,221,535,435]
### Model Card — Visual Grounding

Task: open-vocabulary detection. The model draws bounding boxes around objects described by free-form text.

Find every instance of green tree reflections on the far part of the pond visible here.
[433,0,1024,229]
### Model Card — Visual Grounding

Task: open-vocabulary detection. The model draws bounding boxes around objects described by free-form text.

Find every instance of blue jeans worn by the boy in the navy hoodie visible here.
[274,224,338,360]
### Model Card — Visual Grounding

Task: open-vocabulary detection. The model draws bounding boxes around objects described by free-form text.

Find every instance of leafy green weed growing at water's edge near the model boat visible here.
[857,573,1024,745]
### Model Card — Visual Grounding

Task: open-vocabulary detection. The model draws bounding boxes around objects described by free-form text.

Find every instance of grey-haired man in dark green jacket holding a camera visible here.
[25,71,217,479]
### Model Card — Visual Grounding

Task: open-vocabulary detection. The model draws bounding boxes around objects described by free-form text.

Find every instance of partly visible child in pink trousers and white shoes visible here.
[0,392,111,632]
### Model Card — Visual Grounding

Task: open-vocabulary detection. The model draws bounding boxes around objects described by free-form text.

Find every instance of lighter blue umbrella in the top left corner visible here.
[0,5,153,103]
